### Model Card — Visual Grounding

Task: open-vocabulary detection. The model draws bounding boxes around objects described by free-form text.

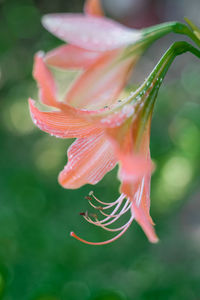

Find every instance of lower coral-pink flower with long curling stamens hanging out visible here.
[29,51,157,244]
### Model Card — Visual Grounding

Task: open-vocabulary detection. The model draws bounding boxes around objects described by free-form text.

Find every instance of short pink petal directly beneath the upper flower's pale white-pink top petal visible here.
[45,45,101,69]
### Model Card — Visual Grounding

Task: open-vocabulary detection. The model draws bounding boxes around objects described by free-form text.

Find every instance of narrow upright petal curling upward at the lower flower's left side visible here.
[33,52,58,107]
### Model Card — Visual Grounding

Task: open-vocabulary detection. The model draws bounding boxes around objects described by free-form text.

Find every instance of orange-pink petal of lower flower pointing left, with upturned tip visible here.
[29,99,101,138]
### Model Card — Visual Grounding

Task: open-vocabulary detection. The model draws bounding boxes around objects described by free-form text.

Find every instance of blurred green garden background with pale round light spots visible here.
[0,0,200,300]
